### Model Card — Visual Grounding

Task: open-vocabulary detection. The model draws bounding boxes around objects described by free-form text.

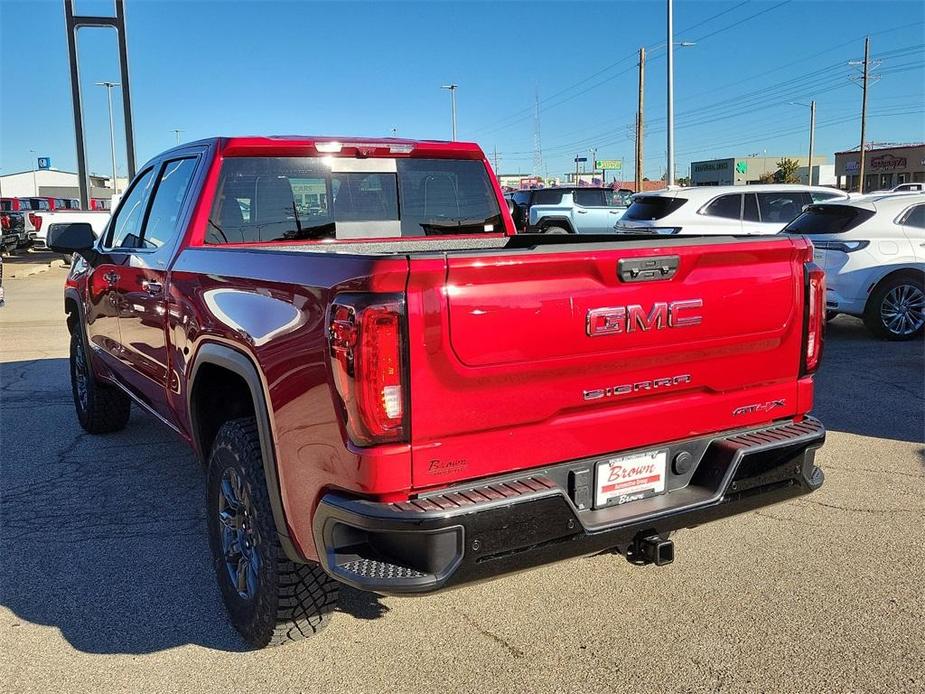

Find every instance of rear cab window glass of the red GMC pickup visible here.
[206,157,504,243]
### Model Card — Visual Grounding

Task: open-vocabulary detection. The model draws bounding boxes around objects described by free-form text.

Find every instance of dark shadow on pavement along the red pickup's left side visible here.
[0,359,388,654]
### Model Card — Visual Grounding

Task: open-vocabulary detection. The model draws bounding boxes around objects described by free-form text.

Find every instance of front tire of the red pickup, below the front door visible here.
[69,327,132,434]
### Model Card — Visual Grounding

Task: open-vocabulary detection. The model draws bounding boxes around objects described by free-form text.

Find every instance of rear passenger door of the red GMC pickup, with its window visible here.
[119,153,199,420]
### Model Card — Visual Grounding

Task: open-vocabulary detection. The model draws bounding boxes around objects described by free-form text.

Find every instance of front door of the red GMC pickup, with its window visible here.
[86,169,154,375]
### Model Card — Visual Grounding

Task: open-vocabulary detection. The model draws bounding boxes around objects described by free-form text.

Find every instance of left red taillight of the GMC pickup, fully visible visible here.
[328,295,405,446]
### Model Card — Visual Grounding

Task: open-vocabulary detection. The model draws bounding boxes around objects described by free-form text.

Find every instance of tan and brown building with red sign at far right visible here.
[835,142,925,193]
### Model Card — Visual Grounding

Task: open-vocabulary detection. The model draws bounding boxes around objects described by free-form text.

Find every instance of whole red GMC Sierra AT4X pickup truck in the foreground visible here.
[49,137,825,646]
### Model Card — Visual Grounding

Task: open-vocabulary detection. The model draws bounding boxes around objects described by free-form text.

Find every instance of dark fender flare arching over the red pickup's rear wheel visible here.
[186,342,305,564]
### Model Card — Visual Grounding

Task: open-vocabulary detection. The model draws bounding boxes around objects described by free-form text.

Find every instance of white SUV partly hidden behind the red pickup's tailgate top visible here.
[614,184,848,234]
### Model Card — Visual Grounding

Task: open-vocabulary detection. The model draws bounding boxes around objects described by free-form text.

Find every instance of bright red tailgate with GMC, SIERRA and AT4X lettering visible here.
[407,238,808,488]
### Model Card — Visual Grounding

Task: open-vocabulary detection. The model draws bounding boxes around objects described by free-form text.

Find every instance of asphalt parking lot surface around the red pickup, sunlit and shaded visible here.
[0,256,925,693]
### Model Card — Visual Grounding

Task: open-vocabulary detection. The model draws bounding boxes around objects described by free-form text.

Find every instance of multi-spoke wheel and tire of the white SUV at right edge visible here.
[864,275,925,341]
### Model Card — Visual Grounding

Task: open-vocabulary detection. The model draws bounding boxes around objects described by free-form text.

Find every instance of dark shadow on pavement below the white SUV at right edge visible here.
[813,316,925,443]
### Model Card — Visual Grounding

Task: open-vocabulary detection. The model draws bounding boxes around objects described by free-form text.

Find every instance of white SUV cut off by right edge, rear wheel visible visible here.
[784,193,925,340]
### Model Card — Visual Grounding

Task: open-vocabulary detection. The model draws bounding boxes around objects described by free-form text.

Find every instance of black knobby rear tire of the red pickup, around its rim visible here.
[206,417,338,648]
